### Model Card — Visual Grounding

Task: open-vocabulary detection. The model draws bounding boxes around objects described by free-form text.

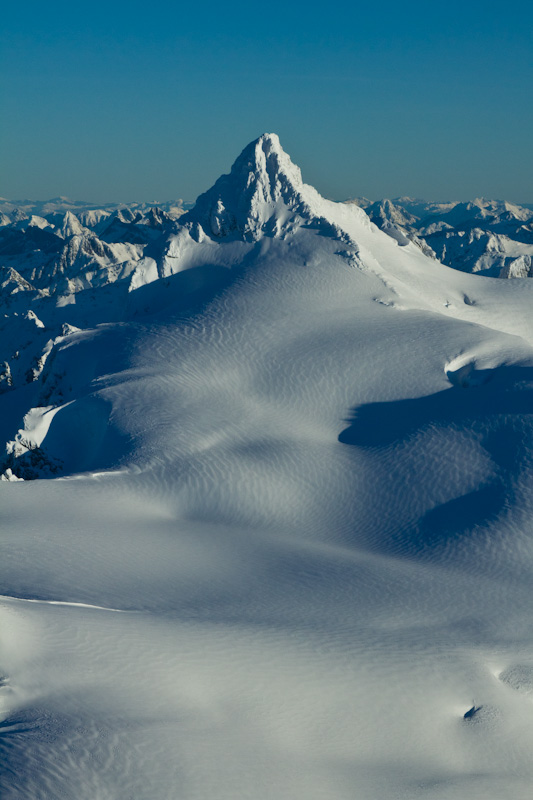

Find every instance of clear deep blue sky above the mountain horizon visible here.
[0,0,533,202]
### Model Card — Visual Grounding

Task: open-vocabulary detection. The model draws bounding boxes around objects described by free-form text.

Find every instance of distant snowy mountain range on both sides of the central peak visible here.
[0,192,533,298]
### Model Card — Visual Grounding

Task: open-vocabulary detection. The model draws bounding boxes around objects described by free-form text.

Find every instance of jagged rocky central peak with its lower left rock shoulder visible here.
[145,134,372,289]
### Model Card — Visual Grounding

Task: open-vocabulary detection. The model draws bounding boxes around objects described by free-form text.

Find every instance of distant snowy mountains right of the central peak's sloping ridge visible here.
[358,197,533,278]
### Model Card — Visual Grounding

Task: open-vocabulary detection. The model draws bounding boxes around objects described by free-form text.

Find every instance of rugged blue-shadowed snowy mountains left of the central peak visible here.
[0,198,190,393]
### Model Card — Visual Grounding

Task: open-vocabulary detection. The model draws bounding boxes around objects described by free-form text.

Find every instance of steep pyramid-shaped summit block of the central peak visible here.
[181,133,340,241]
